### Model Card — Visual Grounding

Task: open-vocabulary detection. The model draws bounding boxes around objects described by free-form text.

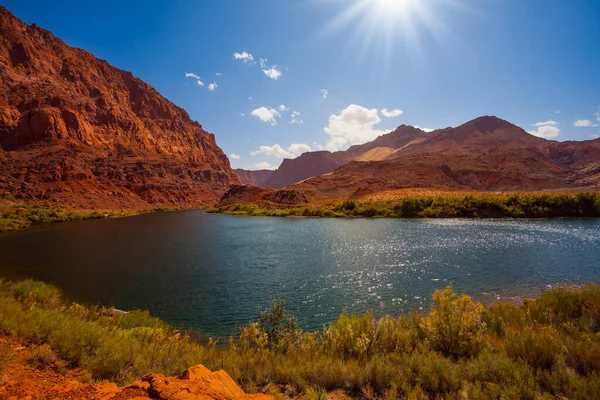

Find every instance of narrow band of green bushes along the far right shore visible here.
[207,192,600,218]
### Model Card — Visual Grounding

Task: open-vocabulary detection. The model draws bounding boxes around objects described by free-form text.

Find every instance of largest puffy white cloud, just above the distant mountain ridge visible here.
[324,104,387,151]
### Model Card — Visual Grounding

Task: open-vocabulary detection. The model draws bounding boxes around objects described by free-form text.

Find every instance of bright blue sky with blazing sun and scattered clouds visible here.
[2,0,600,169]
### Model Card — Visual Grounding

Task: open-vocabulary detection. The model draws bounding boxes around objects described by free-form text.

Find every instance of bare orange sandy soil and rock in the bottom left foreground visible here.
[0,334,284,400]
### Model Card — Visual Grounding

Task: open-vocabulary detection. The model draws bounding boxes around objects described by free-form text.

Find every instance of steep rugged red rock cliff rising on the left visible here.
[0,7,239,208]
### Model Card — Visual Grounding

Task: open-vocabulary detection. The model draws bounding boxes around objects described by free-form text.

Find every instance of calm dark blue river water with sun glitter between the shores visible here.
[0,211,600,336]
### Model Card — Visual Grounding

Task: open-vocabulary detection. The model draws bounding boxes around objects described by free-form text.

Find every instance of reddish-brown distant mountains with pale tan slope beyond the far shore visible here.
[225,116,600,201]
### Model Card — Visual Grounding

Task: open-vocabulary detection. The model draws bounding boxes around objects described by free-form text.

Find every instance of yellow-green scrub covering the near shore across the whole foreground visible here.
[0,280,600,399]
